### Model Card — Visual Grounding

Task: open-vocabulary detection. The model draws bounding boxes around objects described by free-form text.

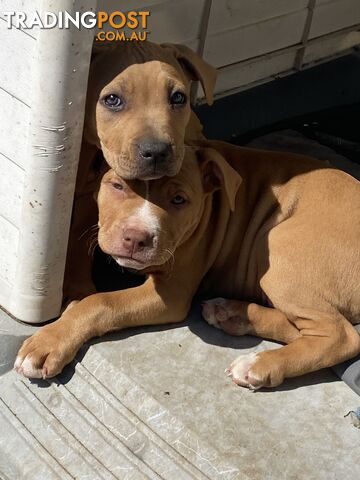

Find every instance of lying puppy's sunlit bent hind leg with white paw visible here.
[229,313,360,389]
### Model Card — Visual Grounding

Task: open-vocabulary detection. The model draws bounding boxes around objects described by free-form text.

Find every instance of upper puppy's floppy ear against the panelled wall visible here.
[161,43,217,105]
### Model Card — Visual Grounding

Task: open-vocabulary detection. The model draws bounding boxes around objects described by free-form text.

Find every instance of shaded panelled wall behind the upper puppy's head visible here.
[98,0,360,95]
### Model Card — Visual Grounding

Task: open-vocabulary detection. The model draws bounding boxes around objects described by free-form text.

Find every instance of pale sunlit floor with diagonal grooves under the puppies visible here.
[0,132,360,480]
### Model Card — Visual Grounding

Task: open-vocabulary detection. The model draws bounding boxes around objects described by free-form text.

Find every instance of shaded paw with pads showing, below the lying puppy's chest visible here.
[202,297,250,335]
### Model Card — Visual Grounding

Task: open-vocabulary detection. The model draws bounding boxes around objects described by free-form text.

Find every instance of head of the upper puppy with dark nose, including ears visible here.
[84,42,216,180]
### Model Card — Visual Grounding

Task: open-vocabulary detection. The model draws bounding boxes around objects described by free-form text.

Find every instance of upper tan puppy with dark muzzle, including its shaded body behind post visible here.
[64,42,216,301]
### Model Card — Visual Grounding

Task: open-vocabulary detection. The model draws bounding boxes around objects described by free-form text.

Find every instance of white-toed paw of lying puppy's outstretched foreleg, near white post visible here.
[14,325,77,379]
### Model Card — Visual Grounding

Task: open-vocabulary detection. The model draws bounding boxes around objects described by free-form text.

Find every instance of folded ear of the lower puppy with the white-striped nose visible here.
[196,148,242,211]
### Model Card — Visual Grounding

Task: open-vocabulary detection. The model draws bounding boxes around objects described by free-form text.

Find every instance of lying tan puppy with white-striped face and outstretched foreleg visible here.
[15,142,360,389]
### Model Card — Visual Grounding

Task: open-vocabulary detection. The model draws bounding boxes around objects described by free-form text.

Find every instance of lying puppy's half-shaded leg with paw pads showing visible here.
[202,298,300,343]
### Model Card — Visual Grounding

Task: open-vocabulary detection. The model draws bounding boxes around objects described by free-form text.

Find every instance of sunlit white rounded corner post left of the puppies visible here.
[11,0,96,323]
